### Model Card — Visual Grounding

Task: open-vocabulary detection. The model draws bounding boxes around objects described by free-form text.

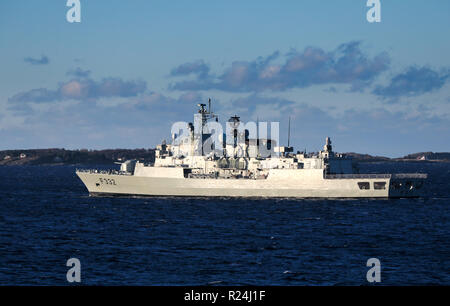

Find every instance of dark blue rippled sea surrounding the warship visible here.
[0,162,450,285]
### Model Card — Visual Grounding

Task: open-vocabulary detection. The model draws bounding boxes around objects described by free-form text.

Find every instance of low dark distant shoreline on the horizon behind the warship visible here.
[0,148,450,166]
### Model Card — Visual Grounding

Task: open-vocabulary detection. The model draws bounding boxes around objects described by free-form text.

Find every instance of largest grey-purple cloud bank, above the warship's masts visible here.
[169,41,390,92]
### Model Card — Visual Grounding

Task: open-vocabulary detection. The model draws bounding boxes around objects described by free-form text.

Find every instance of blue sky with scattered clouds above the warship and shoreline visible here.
[0,0,450,157]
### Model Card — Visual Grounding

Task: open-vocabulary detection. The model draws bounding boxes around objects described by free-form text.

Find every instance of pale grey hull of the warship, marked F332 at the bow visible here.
[77,172,420,198]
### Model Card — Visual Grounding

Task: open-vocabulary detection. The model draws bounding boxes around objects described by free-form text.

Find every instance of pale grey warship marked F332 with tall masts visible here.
[76,100,427,198]
